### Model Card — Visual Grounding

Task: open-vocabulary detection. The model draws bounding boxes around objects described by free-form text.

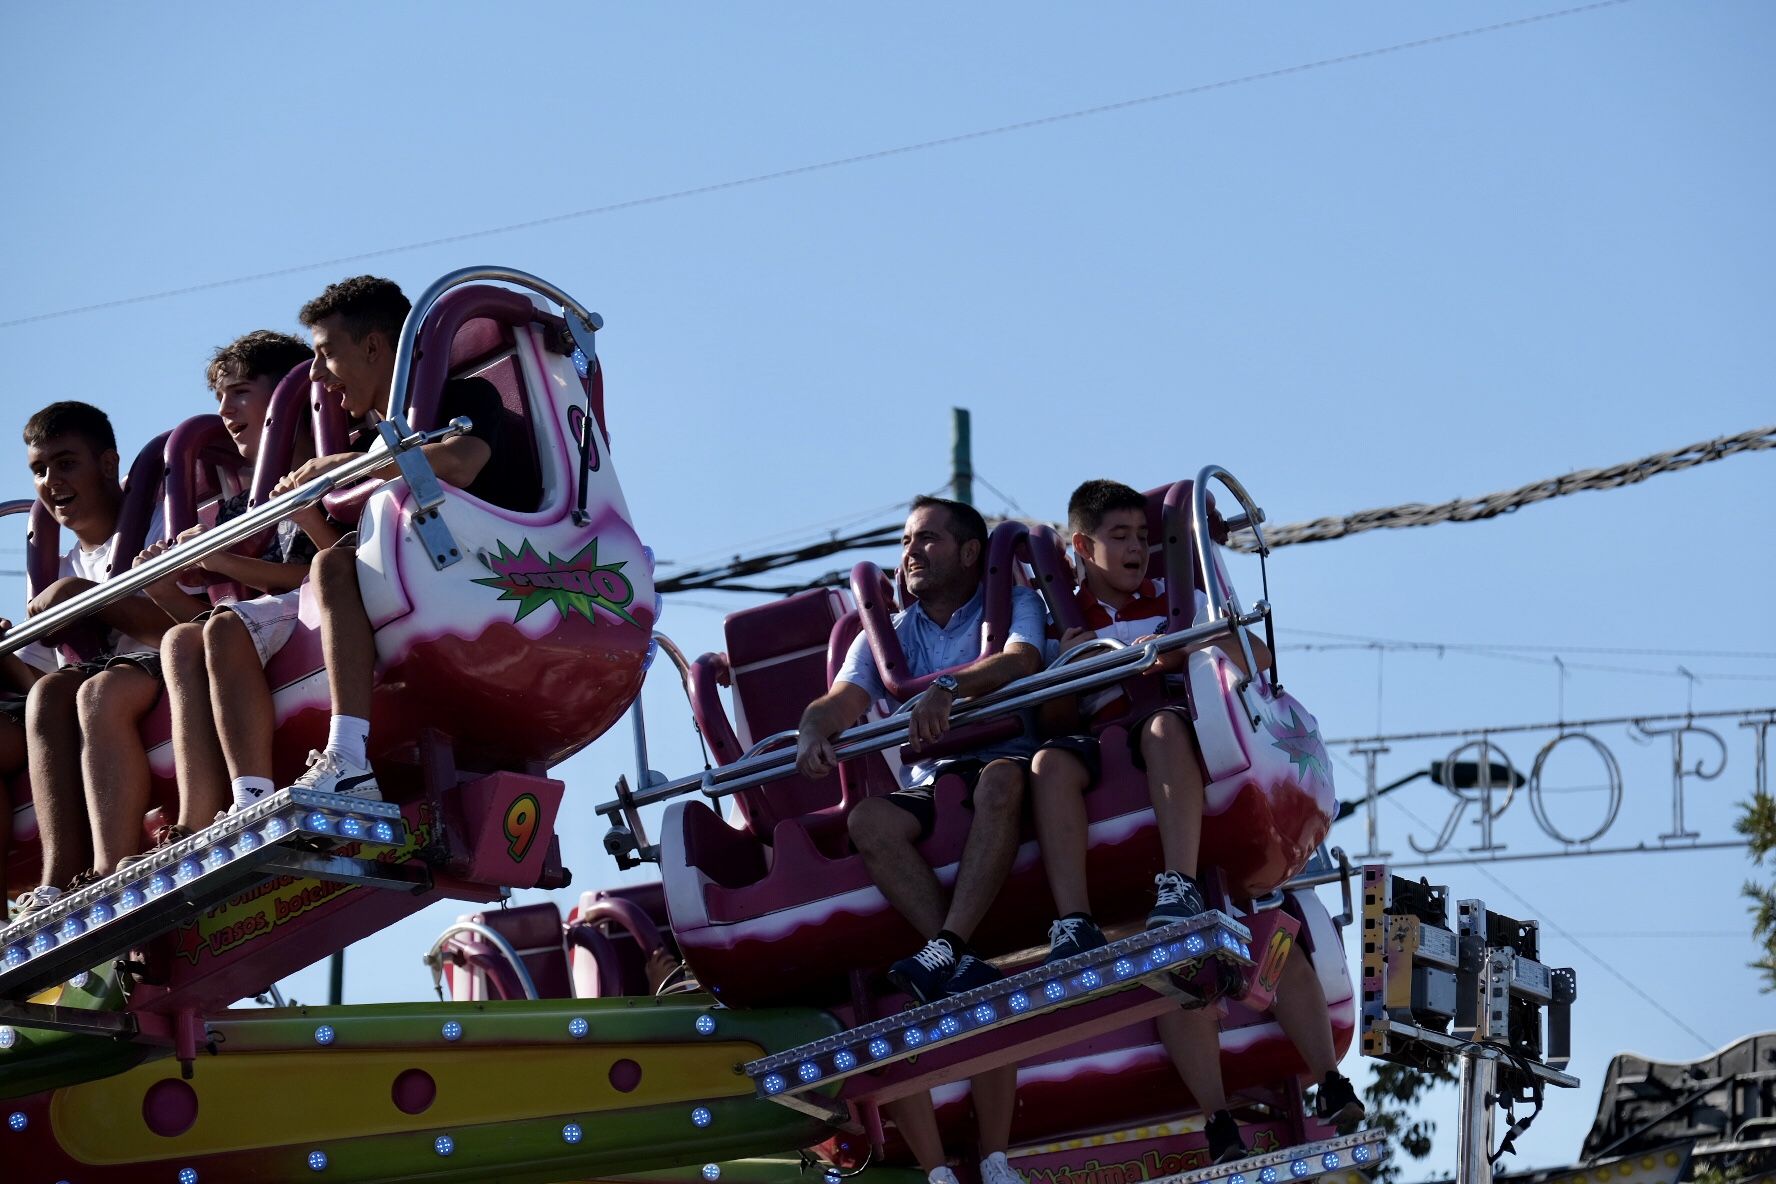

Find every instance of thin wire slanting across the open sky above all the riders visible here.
[0,0,1629,328]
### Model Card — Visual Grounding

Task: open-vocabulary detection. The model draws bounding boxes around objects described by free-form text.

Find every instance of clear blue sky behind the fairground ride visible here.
[0,0,1776,1177]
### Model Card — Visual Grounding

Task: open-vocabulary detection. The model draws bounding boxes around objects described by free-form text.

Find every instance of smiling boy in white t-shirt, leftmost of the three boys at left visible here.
[9,401,184,911]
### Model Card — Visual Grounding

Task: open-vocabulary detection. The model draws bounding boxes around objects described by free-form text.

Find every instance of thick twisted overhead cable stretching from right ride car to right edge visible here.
[1229,424,1776,550]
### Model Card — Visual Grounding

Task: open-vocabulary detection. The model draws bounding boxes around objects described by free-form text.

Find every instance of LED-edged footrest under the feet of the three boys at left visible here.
[0,790,416,999]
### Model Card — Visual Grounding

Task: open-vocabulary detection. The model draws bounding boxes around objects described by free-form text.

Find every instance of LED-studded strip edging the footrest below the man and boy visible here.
[741,912,1252,1099]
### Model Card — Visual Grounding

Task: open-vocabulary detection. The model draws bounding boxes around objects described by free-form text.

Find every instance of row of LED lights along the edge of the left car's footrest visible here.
[0,790,407,994]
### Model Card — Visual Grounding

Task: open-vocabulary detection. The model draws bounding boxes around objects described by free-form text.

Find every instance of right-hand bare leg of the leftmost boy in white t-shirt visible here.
[76,662,160,875]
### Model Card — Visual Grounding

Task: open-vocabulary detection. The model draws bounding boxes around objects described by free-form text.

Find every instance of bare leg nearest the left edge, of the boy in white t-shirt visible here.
[25,671,92,888]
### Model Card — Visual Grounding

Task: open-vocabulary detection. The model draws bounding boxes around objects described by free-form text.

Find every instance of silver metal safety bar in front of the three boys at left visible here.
[0,415,472,653]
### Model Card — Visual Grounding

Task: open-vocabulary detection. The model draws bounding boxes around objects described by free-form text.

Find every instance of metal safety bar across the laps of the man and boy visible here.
[597,611,1263,817]
